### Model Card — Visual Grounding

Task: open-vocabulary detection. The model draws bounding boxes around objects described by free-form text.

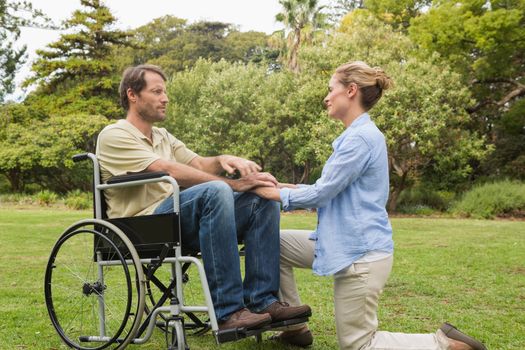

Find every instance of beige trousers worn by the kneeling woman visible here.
[280,230,448,350]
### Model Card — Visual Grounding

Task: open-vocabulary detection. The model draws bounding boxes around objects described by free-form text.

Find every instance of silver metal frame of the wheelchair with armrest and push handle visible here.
[45,153,219,350]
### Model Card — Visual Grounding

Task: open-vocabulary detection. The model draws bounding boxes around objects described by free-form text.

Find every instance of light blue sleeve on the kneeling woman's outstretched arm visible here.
[279,136,371,211]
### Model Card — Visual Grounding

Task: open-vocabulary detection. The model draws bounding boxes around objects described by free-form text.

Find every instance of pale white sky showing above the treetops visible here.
[10,0,282,100]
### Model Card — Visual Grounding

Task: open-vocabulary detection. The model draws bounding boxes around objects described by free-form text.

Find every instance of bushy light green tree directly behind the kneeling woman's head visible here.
[301,10,490,211]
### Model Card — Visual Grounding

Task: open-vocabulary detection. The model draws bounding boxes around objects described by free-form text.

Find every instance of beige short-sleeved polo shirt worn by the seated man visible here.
[96,119,197,218]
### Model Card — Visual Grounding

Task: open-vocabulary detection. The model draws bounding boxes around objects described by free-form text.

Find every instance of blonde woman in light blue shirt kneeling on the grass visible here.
[252,62,485,350]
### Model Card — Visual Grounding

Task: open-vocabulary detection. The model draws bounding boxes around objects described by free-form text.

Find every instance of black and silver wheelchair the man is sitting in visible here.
[44,153,308,350]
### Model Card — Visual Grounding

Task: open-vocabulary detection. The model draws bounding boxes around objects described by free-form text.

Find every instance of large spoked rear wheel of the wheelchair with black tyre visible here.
[44,219,145,350]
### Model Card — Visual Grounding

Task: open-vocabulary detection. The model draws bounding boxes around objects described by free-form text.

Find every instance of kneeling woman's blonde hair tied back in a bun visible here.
[335,61,394,111]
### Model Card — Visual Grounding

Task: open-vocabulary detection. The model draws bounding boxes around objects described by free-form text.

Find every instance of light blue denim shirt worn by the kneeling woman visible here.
[280,113,394,275]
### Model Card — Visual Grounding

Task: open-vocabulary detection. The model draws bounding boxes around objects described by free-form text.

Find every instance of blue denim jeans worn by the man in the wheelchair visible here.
[154,181,280,321]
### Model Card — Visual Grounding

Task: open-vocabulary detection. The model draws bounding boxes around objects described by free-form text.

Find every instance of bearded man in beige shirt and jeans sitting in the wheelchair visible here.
[96,65,311,329]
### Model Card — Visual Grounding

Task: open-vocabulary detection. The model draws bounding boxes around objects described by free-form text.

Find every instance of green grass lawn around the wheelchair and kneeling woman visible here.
[0,208,525,350]
